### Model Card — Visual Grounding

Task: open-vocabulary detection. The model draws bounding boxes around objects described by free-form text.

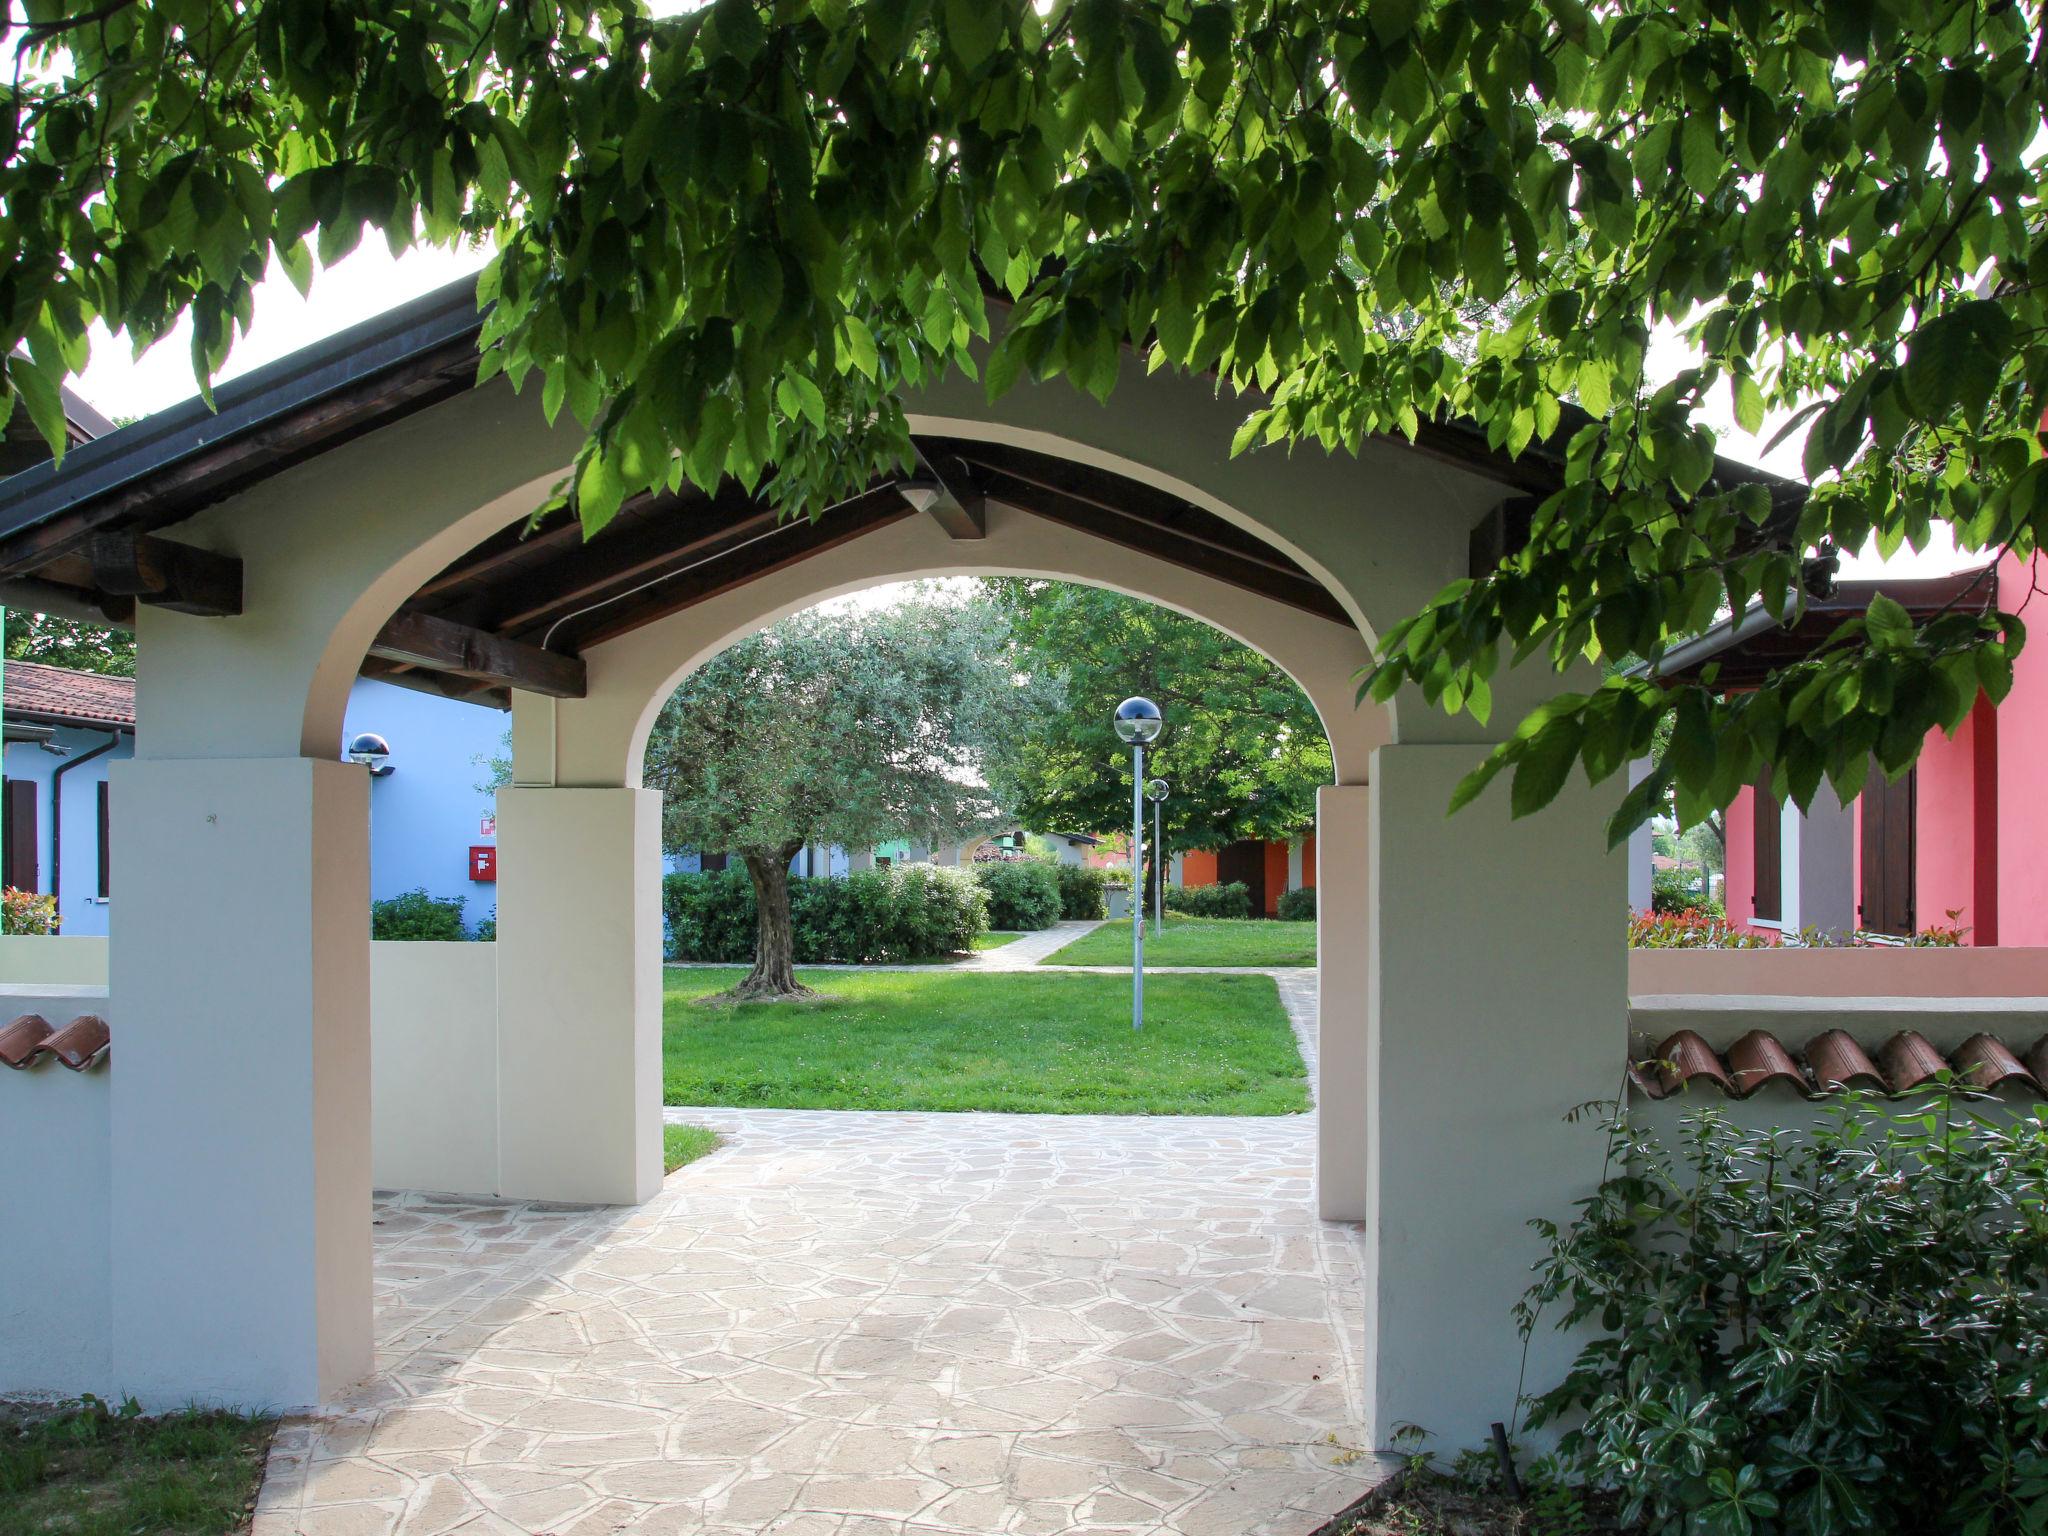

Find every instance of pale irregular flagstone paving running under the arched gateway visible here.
[252,983,1380,1536]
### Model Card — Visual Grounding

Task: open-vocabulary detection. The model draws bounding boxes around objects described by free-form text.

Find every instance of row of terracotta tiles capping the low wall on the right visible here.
[1628,1030,2048,1098]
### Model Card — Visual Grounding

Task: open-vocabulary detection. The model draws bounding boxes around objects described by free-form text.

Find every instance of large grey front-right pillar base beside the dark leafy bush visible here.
[1368,745,1628,1450]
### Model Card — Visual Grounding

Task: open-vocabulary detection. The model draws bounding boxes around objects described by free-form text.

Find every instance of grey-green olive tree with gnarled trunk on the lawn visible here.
[647,596,1016,1001]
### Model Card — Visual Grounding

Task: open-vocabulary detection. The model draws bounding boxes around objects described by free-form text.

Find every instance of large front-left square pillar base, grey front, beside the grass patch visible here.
[102,758,371,1409]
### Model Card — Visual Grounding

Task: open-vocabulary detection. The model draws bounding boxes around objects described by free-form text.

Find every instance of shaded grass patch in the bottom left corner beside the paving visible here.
[0,1397,276,1536]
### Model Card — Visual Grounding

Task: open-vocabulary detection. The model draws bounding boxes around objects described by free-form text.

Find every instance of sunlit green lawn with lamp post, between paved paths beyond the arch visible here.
[662,969,1309,1114]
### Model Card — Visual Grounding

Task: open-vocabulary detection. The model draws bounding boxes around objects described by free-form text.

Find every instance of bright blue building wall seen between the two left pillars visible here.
[342,678,512,928]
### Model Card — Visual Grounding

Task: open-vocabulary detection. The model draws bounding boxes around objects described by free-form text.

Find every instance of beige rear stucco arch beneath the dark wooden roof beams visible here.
[514,502,1391,788]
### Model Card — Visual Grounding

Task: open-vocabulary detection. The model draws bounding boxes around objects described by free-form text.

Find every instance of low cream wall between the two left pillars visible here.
[371,942,498,1194]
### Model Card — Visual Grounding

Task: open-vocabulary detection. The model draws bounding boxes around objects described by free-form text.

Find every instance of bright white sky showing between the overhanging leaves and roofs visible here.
[76,246,1982,581]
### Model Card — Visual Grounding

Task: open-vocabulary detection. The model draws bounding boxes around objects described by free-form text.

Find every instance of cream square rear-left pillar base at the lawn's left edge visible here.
[496,788,662,1204]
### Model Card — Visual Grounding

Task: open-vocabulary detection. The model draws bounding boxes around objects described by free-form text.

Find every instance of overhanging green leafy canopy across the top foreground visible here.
[0,0,2048,831]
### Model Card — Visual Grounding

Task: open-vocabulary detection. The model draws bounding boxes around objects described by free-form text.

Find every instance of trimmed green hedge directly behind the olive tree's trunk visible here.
[662,864,989,965]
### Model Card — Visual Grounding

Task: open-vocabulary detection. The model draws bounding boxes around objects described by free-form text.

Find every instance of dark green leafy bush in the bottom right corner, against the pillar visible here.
[1518,1096,2048,1536]
